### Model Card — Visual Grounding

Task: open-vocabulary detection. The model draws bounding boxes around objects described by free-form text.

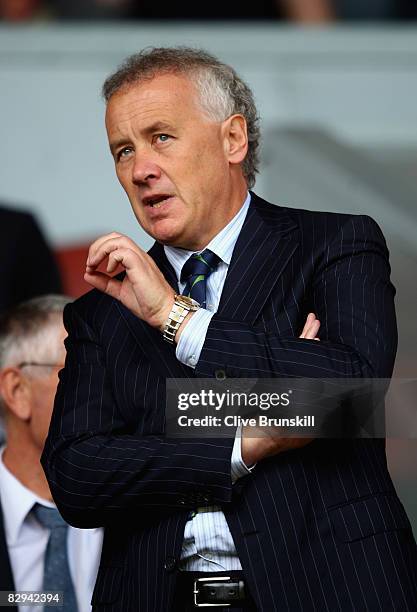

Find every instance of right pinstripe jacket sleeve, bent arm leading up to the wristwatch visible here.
[196,216,397,378]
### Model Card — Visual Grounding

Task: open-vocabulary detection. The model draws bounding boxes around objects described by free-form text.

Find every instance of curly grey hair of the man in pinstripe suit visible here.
[103,47,260,189]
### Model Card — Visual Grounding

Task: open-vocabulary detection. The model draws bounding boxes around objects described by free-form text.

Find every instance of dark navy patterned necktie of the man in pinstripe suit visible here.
[181,249,220,308]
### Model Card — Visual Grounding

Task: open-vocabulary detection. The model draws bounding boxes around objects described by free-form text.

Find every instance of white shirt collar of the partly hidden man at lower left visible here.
[0,446,55,546]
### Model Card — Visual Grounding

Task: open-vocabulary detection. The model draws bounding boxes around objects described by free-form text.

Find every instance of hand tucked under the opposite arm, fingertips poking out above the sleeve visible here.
[241,312,320,466]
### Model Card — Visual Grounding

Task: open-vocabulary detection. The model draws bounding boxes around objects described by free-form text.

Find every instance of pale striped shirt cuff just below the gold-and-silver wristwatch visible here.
[175,308,214,368]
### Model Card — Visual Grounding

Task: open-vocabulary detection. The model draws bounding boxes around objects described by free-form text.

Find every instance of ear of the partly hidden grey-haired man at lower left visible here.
[0,368,32,421]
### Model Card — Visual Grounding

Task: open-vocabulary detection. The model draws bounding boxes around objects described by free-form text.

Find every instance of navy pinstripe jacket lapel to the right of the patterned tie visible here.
[218,193,299,324]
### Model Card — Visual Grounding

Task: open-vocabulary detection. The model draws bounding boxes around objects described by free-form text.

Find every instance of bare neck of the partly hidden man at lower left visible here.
[3,432,52,501]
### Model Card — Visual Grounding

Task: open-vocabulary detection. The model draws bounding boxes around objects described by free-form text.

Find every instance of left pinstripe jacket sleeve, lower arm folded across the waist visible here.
[41,303,233,527]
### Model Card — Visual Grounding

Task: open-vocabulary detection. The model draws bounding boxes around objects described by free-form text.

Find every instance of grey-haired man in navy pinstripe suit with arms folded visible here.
[43,48,417,612]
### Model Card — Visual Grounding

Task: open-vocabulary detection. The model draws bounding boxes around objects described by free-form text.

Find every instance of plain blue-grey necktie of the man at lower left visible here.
[32,504,78,612]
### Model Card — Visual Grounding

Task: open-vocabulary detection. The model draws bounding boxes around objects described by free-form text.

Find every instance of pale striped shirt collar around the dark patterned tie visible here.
[164,193,251,281]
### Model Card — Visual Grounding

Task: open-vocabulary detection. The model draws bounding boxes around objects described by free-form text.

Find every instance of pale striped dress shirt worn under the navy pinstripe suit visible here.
[164,193,250,572]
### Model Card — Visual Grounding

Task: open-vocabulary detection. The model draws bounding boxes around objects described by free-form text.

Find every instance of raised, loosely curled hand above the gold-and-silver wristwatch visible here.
[84,232,174,331]
